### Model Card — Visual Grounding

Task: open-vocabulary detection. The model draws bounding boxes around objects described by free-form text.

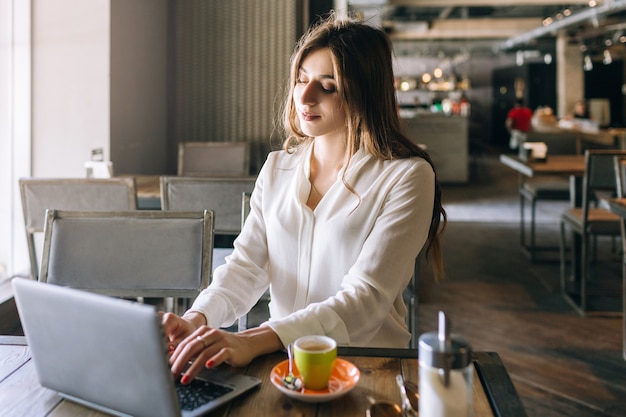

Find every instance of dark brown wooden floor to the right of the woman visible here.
[420,150,626,417]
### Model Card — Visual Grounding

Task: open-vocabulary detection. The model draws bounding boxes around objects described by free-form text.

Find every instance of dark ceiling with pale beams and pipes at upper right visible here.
[349,0,626,57]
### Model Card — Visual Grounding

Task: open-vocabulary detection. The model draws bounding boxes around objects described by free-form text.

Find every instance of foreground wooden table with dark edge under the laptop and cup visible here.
[0,336,526,417]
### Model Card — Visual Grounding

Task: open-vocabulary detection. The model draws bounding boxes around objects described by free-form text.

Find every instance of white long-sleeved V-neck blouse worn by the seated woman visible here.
[191,146,434,348]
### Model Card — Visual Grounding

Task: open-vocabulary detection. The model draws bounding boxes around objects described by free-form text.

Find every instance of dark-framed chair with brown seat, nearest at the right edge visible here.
[560,149,626,315]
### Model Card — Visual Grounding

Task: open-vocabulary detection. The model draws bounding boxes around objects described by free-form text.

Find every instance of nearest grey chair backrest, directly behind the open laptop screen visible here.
[39,210,213,298]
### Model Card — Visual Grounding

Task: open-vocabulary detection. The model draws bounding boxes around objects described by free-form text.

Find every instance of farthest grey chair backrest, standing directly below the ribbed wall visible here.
[178,142,250,177]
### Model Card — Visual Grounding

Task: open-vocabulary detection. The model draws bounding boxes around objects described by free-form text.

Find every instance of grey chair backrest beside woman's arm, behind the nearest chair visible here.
[161,176,256,235]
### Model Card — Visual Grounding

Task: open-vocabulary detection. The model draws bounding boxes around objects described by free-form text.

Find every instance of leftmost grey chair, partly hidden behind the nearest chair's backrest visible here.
[19,178,137,279]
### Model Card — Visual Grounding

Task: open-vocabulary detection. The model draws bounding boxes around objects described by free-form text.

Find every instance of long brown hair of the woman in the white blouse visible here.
[283,13,447,277]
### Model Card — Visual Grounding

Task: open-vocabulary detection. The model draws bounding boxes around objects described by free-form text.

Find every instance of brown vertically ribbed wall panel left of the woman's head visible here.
[170,0,302,172]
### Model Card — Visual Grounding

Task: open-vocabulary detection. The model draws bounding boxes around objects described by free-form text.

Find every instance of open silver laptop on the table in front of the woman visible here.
[12,278,261,417]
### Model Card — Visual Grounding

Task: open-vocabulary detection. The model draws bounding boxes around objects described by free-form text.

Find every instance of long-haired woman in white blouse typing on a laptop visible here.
[163,13,445,383]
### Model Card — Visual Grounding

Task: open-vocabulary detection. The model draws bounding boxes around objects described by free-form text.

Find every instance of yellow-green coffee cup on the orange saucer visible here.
[293,335,337,390]
